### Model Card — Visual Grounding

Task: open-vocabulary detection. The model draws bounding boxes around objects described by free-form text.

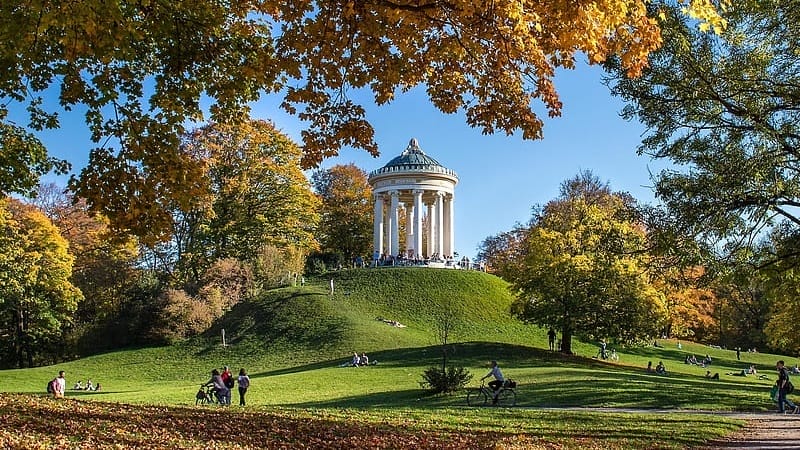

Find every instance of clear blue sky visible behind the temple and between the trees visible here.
[34,59,663,258]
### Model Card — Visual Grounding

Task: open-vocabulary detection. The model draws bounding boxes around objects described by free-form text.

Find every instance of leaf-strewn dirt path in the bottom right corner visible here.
[703,412,800,450]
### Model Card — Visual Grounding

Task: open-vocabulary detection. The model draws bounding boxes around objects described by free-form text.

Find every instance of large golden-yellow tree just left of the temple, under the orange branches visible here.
[165,120,319,281]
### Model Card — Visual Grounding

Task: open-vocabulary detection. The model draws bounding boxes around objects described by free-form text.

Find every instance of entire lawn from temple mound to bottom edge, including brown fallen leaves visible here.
[0,269,796,448]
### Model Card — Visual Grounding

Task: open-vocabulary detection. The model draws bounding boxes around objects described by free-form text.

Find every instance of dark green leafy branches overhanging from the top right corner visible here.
[607,0,800,266]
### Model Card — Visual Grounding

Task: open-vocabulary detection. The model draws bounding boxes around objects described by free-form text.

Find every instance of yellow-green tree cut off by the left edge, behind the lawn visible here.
[0,199,81,367]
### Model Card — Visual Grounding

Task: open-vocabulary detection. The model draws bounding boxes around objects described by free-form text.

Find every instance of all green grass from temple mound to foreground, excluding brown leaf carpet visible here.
[0,269,780,448]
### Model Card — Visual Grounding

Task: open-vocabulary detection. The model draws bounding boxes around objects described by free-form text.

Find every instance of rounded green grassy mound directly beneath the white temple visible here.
[204,268,543,362]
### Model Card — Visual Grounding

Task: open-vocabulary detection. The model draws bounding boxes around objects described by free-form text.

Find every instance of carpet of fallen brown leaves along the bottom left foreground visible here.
[0,394,536,450]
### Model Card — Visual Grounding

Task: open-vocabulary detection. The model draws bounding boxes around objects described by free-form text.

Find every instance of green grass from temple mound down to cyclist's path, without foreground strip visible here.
[2,269,794,410]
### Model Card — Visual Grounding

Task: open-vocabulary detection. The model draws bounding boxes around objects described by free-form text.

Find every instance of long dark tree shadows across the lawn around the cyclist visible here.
[248,342,771,411]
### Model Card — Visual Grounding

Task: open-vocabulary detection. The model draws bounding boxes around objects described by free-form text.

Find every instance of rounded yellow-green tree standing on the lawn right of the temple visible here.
[509,172,665,353]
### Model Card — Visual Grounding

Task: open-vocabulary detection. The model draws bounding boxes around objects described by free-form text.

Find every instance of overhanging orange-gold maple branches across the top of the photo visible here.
[0,0,724,243]
